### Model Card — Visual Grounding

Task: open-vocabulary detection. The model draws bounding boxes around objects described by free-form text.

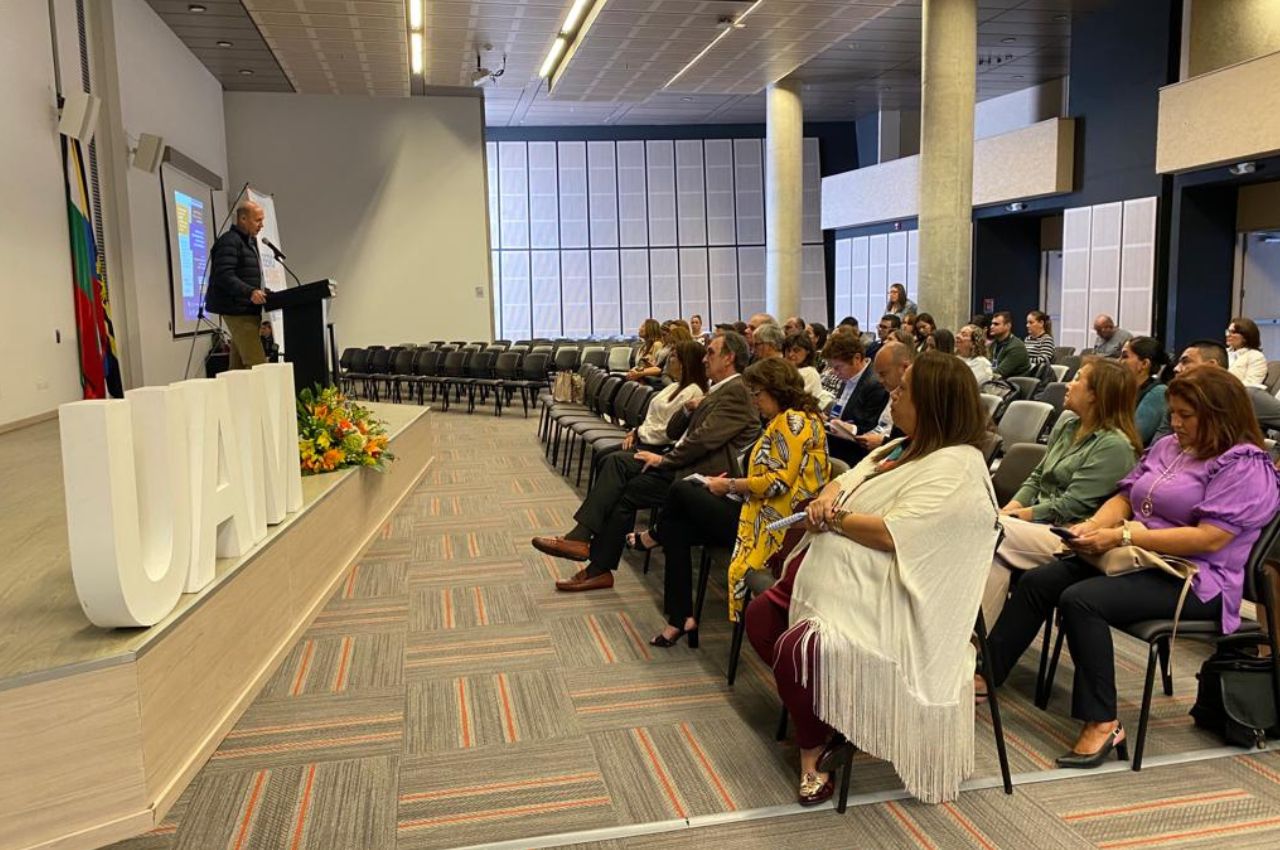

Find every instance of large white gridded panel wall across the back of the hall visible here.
[488,138,829,339]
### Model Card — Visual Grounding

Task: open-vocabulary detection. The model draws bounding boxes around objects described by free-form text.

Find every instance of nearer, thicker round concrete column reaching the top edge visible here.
[915,0,978,328]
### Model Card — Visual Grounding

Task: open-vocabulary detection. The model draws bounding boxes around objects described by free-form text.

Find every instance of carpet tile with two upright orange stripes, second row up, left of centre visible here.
[404,671,581,755]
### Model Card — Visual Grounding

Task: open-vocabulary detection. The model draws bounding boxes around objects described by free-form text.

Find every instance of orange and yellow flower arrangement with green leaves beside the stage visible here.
[298,387,396,475]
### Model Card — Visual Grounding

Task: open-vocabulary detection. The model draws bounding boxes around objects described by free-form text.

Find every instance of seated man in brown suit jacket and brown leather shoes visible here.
[532,332,760,591]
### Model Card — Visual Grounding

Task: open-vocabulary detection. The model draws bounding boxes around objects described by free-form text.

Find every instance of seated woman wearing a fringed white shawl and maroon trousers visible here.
[746,352,998,805]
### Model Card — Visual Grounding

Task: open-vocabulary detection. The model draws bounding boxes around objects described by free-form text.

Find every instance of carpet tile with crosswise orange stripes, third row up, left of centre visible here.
[404,625,559,678]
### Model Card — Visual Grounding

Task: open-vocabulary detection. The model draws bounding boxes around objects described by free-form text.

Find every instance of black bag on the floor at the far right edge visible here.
[1190,635,1280,749]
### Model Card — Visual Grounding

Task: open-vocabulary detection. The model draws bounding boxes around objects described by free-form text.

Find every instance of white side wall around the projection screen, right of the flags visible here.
[101,0,227,385]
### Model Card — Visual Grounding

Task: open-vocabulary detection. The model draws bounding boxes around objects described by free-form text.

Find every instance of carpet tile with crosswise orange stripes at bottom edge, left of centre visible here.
[396,737,617,849]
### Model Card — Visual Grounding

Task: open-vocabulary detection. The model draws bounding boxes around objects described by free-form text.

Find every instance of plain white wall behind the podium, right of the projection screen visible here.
[225,92,493,347]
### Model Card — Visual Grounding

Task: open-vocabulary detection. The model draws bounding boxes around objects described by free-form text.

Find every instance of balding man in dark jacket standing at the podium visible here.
[205,200,266,369]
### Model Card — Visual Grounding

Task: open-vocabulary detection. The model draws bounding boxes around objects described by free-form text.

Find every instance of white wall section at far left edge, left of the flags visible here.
[0,0,81,426]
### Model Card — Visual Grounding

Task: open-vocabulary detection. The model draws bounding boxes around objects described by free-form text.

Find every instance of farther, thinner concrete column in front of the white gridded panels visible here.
[762,81,803,323]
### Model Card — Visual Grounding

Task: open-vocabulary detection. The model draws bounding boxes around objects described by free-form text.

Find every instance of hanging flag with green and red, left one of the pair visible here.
[63,136,124,398]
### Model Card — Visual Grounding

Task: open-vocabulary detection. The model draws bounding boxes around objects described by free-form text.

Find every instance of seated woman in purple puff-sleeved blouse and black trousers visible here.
[989,367,1280,768]
